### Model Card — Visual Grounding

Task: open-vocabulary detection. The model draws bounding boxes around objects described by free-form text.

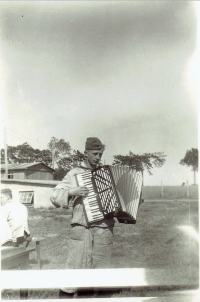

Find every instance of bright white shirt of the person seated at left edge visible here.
[1,201,30,242]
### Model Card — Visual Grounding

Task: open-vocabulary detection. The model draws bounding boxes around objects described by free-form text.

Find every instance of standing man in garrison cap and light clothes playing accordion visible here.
[51,137,115,297]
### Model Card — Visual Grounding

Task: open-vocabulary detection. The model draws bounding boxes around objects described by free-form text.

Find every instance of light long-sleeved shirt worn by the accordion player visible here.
[51,160,115,227]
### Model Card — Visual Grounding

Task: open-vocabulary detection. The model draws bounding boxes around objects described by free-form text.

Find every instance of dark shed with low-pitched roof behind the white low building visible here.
[1,162,55,180]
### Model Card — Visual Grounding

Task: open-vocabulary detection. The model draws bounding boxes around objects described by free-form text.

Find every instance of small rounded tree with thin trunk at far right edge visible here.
[179,148,199,185]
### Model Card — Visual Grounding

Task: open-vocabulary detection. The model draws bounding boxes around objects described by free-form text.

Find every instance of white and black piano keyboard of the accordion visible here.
[76,171,104,223]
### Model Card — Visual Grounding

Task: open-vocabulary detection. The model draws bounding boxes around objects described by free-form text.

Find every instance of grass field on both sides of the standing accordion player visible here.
[2,200,199,299]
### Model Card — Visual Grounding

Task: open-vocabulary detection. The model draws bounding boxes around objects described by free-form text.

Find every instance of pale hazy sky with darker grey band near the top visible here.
[0,1,199,185]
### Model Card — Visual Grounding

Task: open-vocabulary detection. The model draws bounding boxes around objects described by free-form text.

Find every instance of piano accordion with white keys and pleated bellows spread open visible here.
[76,165,143,224]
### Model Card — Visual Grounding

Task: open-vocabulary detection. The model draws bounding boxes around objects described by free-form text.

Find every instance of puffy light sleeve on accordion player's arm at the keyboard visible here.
[50,173,73,208]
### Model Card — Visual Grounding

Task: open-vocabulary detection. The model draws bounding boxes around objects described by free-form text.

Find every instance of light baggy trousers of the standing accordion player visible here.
[61,225,113,293]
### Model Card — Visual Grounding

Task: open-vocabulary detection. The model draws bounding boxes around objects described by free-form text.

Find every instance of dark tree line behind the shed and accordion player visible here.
[1,137,169,180]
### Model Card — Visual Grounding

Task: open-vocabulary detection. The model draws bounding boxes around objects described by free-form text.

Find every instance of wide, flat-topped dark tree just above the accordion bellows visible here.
[113,151,166,175]
